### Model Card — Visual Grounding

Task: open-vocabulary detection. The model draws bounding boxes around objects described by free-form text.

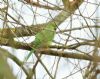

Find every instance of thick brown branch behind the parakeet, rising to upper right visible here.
[0,0,83,37]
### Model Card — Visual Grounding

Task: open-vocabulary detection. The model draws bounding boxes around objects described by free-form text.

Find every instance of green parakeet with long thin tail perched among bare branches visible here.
[26,23,57,60]
